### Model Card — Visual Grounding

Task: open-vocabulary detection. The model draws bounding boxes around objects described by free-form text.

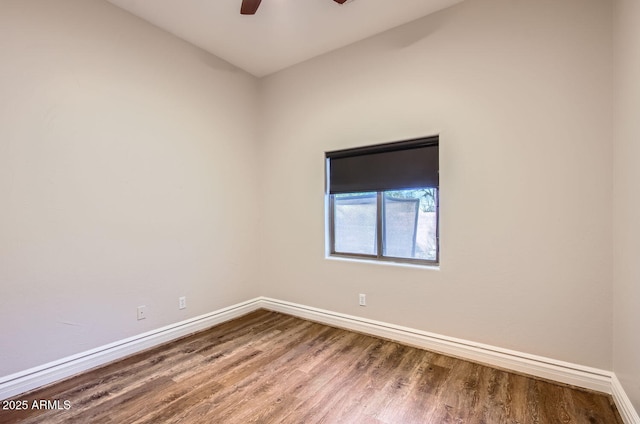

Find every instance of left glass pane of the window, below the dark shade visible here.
[333,193,378,255]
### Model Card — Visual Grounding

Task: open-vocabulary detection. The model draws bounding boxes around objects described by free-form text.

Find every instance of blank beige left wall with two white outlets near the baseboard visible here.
[0,0,258,375]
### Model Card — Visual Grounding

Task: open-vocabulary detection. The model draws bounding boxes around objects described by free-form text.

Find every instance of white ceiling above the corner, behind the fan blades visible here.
[108,0,462,77]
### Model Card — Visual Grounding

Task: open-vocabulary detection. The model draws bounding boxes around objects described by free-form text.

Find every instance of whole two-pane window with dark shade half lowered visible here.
[326,136,439,264]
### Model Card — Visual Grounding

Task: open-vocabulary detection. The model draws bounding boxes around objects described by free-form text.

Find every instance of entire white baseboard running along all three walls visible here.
[0,297,640,424]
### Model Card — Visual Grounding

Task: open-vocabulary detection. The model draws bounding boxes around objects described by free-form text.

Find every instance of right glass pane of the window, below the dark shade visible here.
[382,188,438,261]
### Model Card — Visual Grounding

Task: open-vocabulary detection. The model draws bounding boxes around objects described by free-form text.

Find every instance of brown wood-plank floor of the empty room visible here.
[0,310,622,424]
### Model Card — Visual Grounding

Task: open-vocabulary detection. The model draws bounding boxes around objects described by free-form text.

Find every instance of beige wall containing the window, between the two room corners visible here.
[261,0,612,369]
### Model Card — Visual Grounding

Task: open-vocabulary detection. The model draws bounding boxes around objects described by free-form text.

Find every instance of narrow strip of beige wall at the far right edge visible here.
[613,0,640,411]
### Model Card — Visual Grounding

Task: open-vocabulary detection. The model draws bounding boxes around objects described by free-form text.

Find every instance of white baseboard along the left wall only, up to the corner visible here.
[0,298,260,400]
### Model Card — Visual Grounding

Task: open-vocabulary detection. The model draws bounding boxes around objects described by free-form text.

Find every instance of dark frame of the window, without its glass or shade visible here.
[325,136,440,267]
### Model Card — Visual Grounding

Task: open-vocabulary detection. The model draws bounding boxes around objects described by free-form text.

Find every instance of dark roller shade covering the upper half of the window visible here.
[326,137,438,194]
